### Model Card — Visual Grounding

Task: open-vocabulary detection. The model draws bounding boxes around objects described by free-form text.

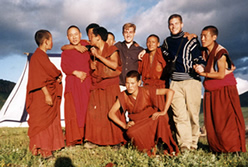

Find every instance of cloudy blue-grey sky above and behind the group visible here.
[0,0,248,90]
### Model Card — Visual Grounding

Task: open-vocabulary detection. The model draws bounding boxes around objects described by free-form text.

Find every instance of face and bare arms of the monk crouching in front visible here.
[108,77,174,130]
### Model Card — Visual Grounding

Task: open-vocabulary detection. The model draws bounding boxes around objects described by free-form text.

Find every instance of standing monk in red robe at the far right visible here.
[194,26,246,152]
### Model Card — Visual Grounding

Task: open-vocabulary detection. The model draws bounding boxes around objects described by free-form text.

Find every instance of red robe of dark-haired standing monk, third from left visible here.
[85,44,125,145]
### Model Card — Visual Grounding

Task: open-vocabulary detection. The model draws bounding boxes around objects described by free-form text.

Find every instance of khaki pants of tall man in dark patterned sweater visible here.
[170,79,202,149]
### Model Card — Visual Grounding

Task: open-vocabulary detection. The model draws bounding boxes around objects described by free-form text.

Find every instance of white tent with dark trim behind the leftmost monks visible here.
[0,53,65,127]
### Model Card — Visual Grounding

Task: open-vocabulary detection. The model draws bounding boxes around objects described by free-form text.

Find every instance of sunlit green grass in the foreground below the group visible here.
[0,128,248,167]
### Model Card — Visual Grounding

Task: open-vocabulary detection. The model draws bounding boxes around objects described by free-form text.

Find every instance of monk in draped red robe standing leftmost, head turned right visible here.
[26,30,64,159]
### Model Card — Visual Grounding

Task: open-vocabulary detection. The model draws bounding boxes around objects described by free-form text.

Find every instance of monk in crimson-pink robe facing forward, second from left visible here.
[61,25,91,146]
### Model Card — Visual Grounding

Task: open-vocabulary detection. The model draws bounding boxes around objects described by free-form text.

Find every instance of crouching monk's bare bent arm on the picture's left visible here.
[108,99,129,129]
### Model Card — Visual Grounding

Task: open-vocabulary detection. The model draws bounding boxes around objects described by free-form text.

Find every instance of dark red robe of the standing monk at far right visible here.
[203,43,246,152]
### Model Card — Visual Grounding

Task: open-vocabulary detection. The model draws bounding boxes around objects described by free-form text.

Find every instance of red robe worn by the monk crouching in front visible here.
[118,87,179,154]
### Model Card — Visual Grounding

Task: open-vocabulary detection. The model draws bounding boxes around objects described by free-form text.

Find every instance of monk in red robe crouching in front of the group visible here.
[109,71,179,155]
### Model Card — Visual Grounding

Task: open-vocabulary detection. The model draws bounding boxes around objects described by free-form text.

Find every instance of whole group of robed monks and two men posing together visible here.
[26,14,246,158]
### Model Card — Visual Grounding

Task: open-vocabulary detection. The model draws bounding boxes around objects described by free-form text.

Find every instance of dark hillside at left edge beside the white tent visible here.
[0,79,15,108]
